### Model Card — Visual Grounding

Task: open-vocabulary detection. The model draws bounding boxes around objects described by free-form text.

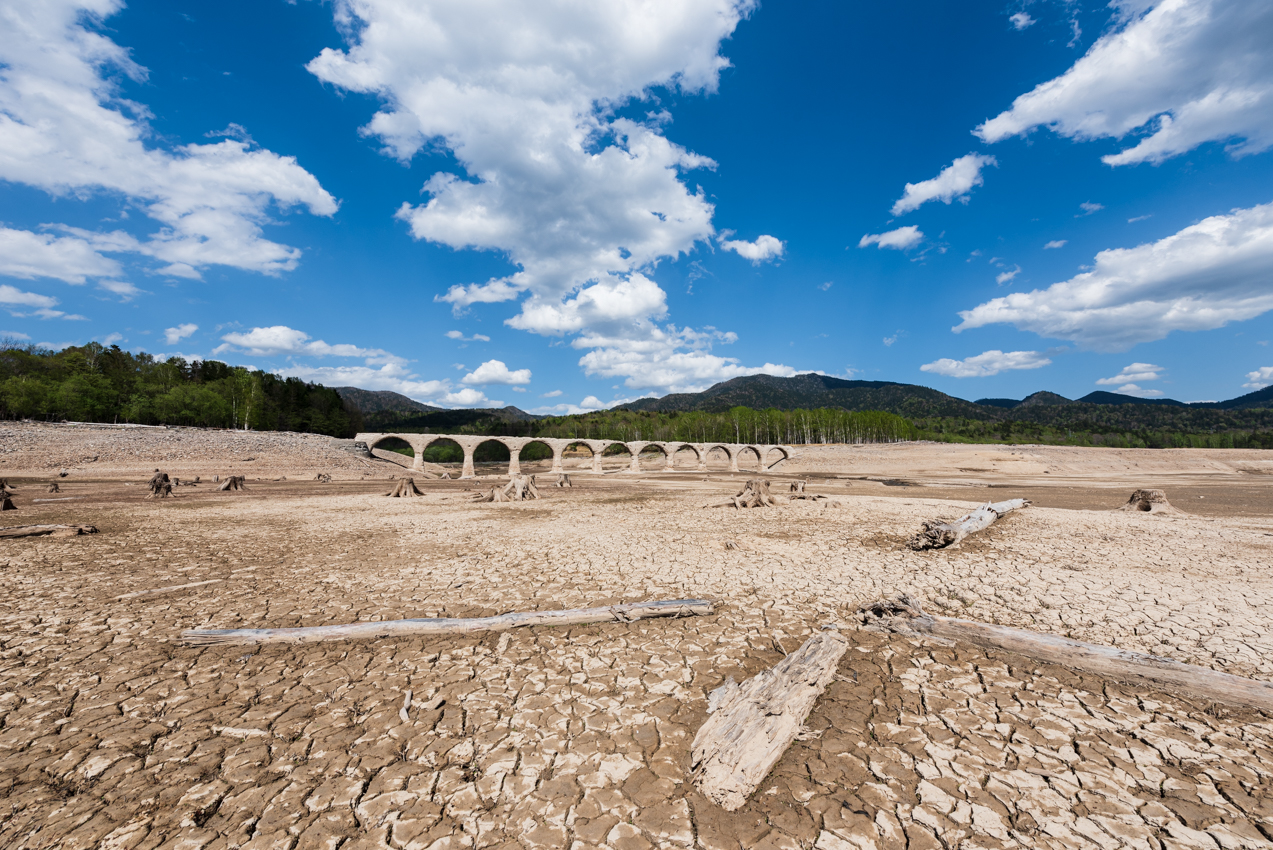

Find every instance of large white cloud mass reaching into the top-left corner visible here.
[0,0,336,282]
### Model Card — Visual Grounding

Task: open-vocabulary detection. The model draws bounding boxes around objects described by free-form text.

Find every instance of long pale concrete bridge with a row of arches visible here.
[354,433,796,478]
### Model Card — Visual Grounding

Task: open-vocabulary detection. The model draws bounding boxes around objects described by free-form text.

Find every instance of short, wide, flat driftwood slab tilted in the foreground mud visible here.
[690,630,849,812]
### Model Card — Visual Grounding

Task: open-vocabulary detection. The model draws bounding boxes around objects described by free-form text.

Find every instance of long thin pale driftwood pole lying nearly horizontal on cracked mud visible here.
[181,599,715,646]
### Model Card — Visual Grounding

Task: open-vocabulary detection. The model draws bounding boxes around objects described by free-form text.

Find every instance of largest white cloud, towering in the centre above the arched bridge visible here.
[308,0,782,394]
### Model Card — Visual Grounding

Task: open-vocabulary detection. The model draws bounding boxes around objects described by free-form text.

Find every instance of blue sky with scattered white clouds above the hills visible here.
[0,0,1273,412]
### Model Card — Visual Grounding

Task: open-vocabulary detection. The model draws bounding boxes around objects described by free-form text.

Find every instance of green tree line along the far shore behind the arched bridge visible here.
[0,340,1273,450]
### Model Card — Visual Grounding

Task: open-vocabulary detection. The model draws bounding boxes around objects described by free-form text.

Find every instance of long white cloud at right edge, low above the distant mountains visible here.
[955,204,1273,351]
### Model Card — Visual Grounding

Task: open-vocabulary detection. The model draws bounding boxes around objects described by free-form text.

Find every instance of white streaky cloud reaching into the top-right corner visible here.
[976,0,1273,165]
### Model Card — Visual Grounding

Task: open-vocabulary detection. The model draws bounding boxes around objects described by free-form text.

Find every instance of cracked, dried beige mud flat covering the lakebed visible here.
[0,426,1273,850]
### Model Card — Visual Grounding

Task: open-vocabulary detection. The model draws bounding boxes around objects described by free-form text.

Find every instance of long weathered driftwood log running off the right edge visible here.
[858,594,1273,714]
